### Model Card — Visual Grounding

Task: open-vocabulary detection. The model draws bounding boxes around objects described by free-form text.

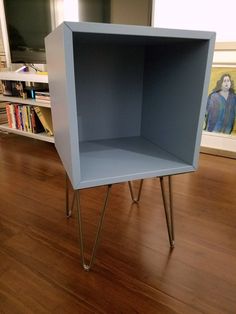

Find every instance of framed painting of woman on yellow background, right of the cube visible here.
[201,42,236,158]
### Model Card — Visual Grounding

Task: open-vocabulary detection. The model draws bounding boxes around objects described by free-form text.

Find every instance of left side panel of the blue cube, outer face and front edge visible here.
[45,23,80,187]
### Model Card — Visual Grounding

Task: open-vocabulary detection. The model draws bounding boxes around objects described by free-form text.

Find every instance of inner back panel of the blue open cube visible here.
[74,42,144,141]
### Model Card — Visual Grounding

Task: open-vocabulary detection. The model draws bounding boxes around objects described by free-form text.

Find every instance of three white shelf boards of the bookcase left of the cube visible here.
[0,71,54,143]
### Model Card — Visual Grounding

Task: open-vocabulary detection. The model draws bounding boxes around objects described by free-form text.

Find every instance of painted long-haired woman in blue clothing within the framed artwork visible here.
[205,73,236,134]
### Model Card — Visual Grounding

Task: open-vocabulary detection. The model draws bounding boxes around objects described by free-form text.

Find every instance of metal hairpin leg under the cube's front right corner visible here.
[160,176,175,248]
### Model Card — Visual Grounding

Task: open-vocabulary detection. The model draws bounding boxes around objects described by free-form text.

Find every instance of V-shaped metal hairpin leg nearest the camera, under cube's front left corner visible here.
[75,184,112,271]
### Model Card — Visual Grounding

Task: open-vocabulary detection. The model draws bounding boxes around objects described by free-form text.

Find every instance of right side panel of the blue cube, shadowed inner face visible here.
[142,39,215,167]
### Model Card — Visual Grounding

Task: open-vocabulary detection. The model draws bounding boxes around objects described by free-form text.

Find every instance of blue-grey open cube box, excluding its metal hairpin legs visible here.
[46,22,215,189]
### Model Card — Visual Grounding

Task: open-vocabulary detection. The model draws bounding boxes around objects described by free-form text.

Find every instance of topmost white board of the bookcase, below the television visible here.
[0,71,48,83]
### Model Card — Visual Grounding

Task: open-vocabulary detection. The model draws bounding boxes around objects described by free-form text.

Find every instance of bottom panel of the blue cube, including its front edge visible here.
[78,137,194,188]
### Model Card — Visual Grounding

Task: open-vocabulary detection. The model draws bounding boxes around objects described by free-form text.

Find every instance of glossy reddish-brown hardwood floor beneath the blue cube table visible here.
[0,134,236,314]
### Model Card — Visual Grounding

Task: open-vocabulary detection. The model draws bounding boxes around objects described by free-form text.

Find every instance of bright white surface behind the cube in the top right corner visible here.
[154,0,236,42]
